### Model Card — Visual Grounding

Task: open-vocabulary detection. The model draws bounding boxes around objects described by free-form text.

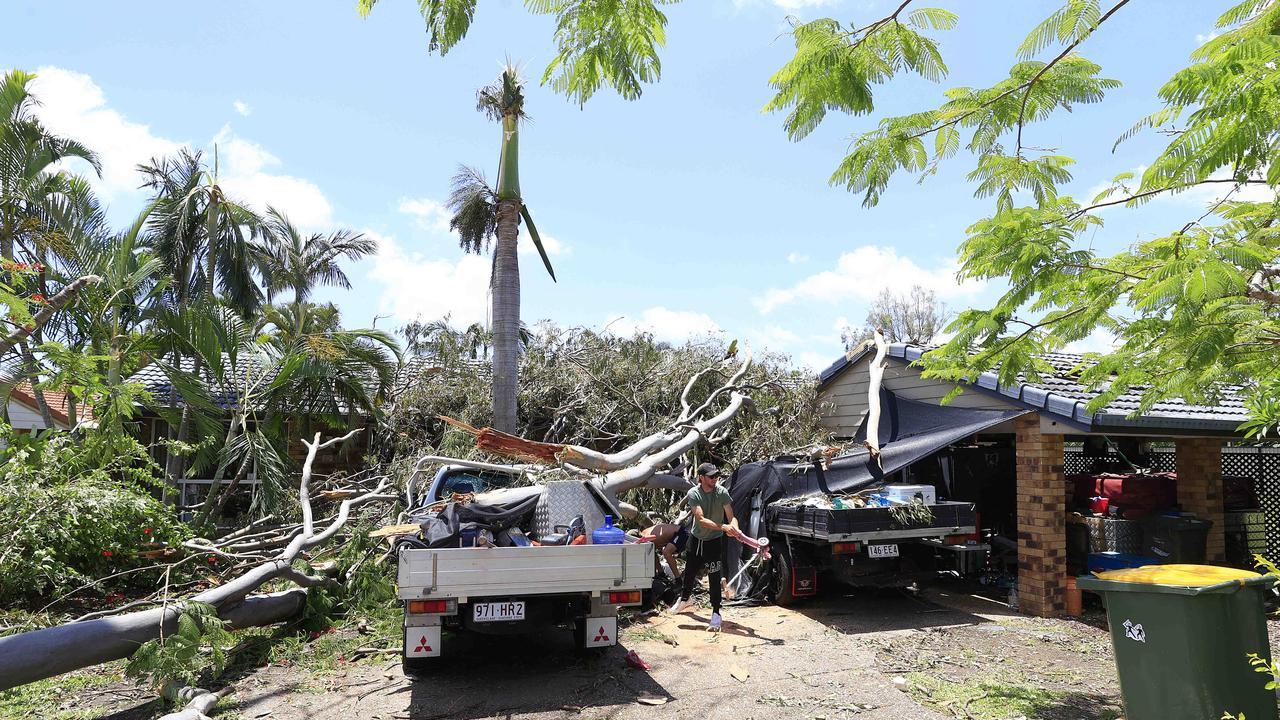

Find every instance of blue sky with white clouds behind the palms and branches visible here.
[0,0,1229,368]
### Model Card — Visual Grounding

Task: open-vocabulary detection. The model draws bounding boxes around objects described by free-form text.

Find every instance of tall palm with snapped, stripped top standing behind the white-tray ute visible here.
[448,63,556,433]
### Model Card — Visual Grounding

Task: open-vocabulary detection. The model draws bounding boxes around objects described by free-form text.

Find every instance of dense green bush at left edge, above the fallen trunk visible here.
[0,427,187,602]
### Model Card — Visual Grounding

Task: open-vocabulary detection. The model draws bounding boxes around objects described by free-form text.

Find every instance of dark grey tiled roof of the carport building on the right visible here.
[818,342,1248,433]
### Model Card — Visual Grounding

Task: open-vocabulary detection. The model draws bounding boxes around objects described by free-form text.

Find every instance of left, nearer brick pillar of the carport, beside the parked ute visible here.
[1016,414,1069,618]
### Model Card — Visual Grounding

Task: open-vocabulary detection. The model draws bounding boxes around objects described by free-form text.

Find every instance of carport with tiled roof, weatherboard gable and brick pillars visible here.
[818,343,1245,616]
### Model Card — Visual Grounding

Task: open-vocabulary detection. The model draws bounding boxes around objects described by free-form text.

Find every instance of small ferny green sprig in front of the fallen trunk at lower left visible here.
[125,601,236,687]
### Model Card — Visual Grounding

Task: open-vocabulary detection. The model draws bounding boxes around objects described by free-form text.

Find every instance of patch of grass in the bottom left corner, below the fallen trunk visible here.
[0,661,160,720]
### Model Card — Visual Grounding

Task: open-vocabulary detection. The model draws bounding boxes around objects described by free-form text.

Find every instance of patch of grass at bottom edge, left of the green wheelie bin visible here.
[906,673,1121,720]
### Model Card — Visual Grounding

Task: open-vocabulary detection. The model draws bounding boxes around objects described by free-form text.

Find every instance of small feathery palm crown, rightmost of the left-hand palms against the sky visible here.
[259,206,378,302]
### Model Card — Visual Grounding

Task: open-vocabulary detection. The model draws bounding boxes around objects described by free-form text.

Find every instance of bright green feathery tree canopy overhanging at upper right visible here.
[767,0,1280,433]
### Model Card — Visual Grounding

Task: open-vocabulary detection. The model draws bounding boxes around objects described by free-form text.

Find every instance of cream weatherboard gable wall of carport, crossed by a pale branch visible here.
[818,354,1019,437]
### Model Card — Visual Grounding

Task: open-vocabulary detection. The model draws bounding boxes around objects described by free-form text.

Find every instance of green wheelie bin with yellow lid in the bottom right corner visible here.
[1076,565,1277,720]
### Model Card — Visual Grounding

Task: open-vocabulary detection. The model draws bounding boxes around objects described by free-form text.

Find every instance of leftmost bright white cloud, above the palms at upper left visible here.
[31,65,182,201]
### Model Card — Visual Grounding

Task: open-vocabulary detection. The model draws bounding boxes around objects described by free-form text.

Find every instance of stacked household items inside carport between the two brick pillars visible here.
[1066,473,1212,571]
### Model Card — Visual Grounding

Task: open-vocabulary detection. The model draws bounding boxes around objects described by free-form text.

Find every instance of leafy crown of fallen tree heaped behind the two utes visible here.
[388,323,824,499]
